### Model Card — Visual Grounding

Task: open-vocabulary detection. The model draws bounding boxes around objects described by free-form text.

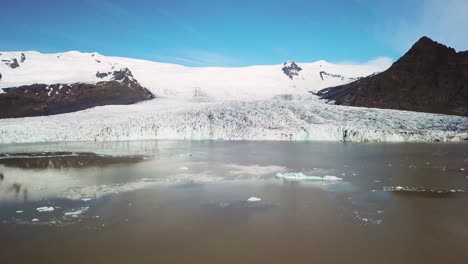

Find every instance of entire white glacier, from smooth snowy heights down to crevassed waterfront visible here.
[0,51,468,144]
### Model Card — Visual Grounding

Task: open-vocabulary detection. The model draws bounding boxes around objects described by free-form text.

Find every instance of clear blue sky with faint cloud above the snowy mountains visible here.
[0,0,468,66]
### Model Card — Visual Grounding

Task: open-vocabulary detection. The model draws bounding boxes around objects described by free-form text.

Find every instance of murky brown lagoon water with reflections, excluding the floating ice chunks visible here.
[0,141,468,263]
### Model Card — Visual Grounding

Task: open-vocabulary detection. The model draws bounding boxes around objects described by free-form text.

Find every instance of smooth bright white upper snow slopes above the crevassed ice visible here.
[0,51,385,100]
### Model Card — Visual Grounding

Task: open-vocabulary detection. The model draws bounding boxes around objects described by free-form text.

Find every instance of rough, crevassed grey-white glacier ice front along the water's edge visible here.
[0,95,468,143]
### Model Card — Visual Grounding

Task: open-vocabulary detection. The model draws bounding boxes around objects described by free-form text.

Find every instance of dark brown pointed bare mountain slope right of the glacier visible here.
[318,37,468,116]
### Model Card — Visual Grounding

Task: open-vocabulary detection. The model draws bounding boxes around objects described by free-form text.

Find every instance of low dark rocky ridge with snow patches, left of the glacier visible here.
[0,68,154,118]
